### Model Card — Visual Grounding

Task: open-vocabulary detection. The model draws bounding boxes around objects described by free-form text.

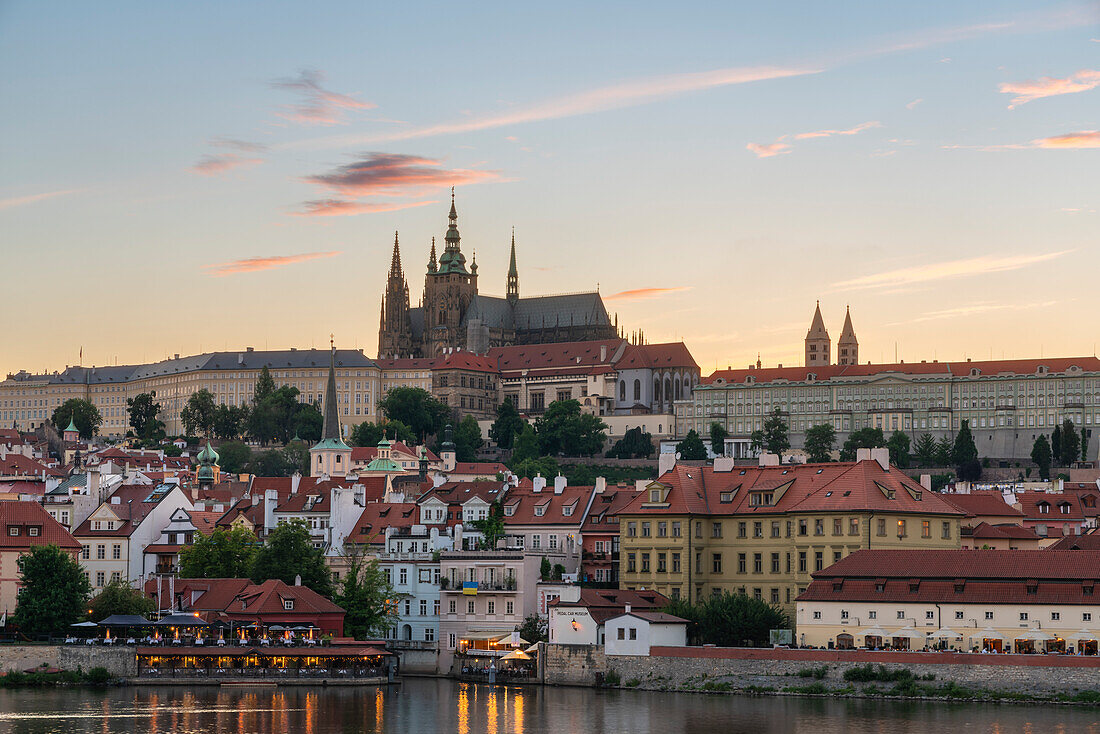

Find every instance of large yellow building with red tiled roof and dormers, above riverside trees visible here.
[619,449,963,613]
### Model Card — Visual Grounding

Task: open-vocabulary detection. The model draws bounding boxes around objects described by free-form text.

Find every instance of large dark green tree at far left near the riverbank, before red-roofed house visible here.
[12,545,91,635]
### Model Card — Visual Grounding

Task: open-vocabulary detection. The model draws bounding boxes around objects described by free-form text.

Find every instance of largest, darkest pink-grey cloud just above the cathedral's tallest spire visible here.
[306,153,501,197]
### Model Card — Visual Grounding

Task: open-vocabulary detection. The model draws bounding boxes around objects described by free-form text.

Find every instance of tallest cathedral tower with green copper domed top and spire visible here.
[421,187,477,357]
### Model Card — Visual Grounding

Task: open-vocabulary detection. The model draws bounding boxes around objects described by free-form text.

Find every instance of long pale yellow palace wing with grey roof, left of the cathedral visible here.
[0,347,380,436]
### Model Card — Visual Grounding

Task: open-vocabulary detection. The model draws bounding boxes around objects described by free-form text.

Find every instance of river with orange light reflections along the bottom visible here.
[0,678,1100,734]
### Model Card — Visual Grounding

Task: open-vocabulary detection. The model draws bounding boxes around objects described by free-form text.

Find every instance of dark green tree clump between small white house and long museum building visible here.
[663,592,791,647]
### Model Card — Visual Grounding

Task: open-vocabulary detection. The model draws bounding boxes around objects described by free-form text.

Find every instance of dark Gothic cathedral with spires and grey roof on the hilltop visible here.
[378,189,618,359]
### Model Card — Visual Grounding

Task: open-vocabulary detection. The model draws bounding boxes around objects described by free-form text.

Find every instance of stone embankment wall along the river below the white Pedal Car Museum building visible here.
[545,645,1100,695]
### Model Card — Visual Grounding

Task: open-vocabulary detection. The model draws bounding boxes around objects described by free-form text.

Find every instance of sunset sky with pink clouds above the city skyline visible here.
[0,0,1100,374]
